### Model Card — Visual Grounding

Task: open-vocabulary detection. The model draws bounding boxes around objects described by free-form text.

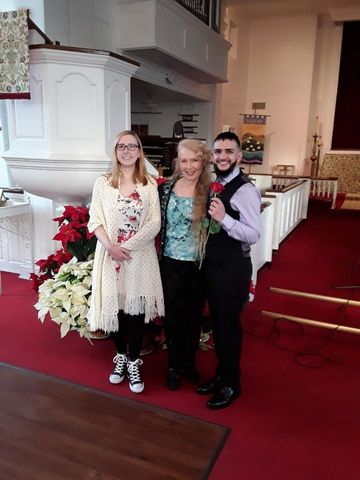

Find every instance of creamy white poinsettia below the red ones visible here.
[35,257,93,340]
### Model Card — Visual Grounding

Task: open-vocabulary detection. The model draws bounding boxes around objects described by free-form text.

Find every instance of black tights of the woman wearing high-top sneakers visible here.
[113,310,145,362]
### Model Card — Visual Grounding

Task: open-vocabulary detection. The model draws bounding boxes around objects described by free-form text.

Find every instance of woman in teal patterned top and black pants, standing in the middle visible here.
[159,139,211,390]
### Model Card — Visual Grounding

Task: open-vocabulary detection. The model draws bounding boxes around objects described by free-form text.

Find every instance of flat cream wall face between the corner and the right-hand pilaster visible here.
[246,15,317,173]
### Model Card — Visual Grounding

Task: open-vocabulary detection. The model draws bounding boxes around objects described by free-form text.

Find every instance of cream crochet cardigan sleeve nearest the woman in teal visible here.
[121,184,160,250]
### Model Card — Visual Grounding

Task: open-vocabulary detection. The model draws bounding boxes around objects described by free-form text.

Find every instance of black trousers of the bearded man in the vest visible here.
[204,258,252,389]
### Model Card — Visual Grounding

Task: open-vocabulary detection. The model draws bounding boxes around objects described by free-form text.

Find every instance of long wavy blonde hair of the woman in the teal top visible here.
[172,138,212,252]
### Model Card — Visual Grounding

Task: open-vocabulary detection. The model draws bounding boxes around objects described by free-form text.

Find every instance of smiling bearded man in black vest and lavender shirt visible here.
[197,132,261,409]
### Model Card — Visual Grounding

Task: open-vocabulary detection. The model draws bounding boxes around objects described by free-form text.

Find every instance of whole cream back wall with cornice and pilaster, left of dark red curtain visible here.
[215,0,360,175]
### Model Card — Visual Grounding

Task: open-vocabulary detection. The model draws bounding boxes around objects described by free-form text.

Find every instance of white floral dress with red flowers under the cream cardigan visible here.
[115,188,143,272]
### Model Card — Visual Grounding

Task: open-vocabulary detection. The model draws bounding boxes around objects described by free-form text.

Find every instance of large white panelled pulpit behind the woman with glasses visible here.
[4,45,139,205]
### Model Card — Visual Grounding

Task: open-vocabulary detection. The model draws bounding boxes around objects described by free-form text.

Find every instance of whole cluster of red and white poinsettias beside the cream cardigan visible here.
[31,206,96,339]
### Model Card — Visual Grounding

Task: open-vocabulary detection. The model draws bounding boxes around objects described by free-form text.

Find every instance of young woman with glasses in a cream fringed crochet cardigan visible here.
[88,130,164,393]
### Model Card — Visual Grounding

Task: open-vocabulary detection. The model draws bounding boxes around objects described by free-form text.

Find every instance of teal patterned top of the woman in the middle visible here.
[164,191,195,261]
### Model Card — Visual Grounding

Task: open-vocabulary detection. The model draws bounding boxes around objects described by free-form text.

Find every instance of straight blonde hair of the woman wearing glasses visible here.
[110,130,149,188]
